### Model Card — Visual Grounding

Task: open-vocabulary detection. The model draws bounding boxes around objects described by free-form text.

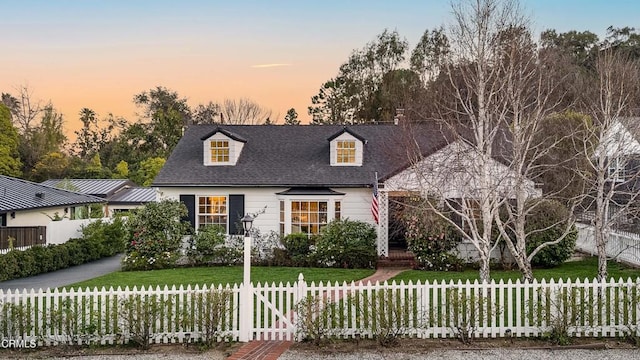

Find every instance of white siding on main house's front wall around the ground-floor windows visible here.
[160,187,374,233]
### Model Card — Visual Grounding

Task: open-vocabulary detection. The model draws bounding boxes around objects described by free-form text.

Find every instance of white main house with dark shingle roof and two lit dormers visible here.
[152,124,533,255]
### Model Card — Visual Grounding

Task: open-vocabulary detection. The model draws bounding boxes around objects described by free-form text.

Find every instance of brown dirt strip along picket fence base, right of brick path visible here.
[291,338,635,355]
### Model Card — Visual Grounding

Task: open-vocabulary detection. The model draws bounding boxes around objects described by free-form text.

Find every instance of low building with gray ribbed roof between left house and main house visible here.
[42,179,156,217]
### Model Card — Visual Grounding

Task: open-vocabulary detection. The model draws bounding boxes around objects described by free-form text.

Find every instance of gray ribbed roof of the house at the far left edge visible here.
[0,175,104,212]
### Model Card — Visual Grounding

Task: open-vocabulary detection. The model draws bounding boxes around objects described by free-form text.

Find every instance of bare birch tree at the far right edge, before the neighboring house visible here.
[582,49,640,280]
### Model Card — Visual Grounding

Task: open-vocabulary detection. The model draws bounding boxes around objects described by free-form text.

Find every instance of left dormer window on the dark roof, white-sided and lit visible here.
[201,128,246,166]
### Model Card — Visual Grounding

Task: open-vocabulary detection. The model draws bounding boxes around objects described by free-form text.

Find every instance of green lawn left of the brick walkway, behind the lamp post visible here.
[66,266,374,289]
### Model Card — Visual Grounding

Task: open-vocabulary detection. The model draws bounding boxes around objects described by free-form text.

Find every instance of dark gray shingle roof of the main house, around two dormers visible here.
[153,123,450,187]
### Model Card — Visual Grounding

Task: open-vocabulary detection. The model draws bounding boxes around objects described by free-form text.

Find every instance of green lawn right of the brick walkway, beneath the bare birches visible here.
[390,257,640,282]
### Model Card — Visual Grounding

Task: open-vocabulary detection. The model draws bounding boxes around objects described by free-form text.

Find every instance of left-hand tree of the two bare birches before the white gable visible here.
[396,0,522,281]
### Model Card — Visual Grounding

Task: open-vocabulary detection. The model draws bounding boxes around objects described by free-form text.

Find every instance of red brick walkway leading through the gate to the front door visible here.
[227,269,404,360]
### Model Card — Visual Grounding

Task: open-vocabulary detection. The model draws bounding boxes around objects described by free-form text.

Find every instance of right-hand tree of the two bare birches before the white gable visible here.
[496,27,579,281]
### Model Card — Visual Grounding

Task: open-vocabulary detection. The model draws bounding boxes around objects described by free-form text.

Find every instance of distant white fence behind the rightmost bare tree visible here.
[576,223,640,266]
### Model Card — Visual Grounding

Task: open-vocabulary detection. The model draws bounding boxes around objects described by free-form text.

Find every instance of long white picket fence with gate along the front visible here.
[0,276,640,345]
